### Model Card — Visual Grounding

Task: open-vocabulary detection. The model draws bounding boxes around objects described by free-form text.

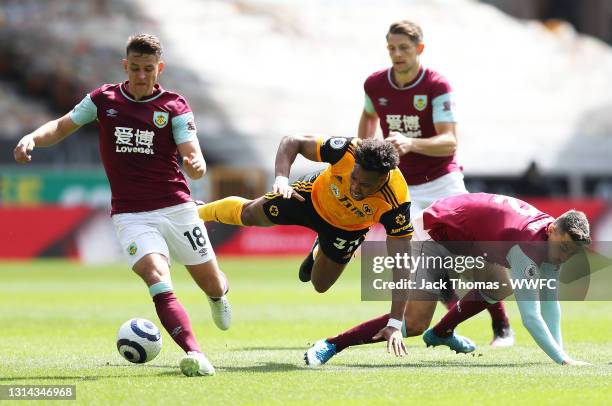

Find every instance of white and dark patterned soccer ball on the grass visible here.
[117,319,162,364]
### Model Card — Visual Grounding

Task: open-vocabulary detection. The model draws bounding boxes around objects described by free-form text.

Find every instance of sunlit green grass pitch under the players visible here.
[0,258,612,405]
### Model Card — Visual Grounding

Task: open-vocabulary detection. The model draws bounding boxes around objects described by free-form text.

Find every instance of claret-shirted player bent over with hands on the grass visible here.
[305,193,591,365]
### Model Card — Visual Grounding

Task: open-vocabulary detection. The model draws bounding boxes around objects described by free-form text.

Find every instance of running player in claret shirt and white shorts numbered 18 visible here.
[14,34,231,376]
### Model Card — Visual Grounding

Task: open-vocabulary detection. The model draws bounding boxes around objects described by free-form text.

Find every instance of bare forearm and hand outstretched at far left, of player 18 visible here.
[13,113,80,164]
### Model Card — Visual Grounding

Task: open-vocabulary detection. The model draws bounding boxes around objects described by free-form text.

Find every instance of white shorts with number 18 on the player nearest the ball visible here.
[112,202,215,267]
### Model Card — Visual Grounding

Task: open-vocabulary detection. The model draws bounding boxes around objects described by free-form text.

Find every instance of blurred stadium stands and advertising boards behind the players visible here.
[0,0,612,263]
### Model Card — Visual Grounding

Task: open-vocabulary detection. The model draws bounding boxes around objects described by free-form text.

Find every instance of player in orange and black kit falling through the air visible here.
[199,135,413,345]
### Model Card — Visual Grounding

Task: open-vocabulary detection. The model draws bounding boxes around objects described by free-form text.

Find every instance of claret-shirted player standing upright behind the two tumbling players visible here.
[358,20,514,347]
